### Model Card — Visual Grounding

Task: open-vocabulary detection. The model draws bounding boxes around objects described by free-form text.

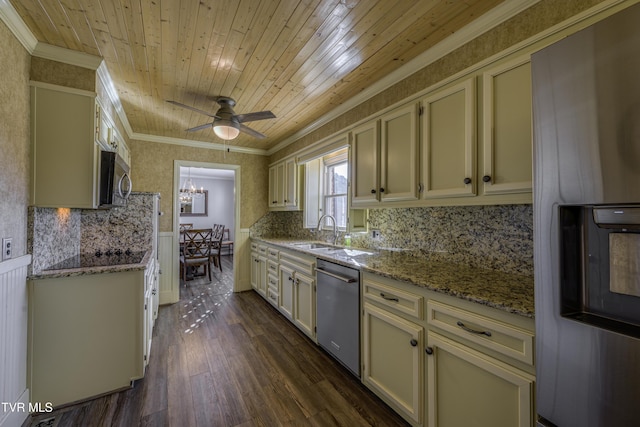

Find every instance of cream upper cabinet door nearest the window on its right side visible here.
[351,120,380,207]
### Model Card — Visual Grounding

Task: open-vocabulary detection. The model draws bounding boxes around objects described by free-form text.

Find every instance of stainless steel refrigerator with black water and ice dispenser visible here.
[532,5,640,427]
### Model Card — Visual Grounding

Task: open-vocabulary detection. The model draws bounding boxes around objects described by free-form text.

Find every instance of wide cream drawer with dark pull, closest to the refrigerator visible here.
[427,301,534,365]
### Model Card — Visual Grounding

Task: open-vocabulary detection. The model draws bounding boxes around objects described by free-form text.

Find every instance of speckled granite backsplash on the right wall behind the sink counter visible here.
[250,205,533,275]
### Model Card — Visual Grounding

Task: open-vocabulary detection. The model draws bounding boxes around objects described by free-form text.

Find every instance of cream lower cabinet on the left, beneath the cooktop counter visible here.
[30,269,153,407]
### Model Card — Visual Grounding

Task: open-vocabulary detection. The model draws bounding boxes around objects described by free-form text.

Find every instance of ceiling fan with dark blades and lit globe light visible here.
[167,96,276,140]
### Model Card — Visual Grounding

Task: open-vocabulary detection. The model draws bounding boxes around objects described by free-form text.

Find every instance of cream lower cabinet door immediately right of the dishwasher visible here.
[363,303,424,423]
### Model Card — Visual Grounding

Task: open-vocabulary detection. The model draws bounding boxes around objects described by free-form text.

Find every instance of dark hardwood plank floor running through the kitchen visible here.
[26,256,406,427]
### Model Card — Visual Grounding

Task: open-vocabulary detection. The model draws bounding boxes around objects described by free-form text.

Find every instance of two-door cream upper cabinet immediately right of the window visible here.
[351,103,418,207]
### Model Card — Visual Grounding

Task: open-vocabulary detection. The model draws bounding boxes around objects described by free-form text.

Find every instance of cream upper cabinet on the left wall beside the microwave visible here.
[31,82,100,209]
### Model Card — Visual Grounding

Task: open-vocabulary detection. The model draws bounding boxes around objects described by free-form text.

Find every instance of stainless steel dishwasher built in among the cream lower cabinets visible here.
[316,259,360,378]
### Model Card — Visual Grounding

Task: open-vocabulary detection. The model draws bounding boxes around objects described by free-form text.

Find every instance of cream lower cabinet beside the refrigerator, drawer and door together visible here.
[425,299,535,427]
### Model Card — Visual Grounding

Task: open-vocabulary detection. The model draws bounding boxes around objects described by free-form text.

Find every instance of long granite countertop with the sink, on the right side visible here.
[253,237,534,318]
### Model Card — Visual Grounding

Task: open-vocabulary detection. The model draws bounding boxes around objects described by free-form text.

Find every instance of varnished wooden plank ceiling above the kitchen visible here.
[10,0,503,149]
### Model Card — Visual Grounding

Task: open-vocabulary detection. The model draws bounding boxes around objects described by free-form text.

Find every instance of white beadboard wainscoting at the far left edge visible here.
[0,255,31,427]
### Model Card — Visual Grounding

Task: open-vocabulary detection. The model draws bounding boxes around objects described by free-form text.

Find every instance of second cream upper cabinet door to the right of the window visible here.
[378,104,418,202]
